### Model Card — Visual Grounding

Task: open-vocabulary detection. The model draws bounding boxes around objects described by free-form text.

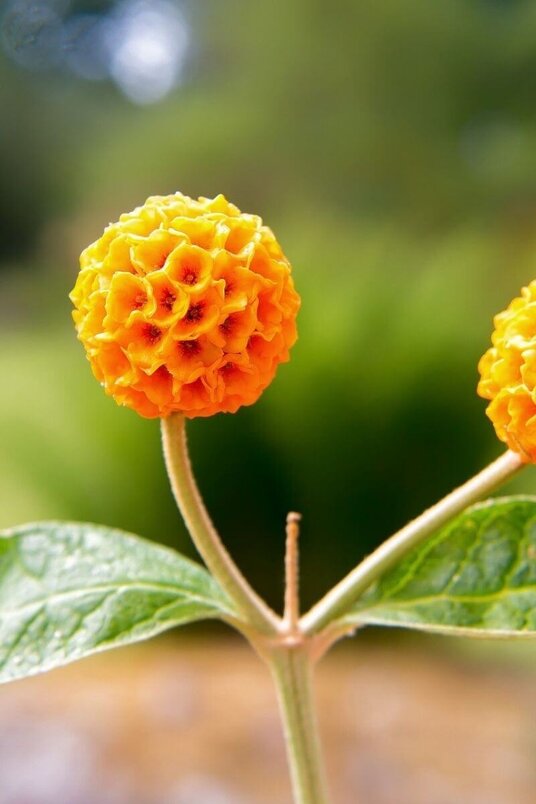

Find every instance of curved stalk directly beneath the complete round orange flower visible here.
[162,413,280,635]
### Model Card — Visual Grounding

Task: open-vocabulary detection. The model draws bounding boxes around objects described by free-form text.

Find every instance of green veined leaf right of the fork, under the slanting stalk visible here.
[342,497,536,637]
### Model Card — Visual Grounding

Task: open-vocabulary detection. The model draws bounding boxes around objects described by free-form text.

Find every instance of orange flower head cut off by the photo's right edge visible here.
[478,281,536,463]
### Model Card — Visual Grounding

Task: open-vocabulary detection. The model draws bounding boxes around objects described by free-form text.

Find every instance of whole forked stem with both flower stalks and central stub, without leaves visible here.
[162,414,524,804]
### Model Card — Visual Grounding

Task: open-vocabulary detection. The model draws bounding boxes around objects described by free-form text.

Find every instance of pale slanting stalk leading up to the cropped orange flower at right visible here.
[300,450,527,634]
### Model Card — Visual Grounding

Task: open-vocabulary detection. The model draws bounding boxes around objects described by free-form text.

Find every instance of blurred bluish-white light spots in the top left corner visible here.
[1,0,189,104]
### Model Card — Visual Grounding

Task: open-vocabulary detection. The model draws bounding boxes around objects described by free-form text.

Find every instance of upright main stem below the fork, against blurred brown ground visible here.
[268,644,328,804]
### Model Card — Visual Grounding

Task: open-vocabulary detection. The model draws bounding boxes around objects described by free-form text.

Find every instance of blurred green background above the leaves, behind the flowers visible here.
[0,0,536,616]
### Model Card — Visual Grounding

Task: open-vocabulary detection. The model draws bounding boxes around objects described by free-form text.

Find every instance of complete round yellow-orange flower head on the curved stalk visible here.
[70,193,300,418]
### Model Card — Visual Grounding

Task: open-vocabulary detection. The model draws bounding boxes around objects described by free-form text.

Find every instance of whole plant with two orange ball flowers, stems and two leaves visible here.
[0,193,536,804]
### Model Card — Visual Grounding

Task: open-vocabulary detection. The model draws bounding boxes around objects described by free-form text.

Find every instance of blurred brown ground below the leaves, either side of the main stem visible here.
[0,639,536,804]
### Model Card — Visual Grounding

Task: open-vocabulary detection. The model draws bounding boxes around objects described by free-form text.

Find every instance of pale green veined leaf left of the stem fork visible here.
[0,522,234,682]
